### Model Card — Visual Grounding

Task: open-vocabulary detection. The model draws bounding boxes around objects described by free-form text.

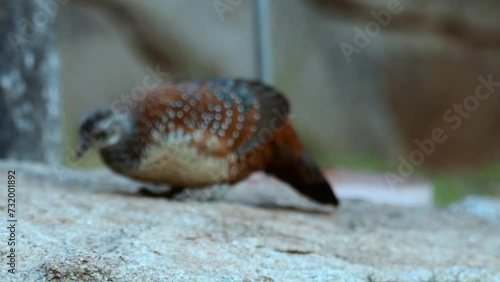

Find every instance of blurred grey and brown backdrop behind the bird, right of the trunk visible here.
[2,0,500,205]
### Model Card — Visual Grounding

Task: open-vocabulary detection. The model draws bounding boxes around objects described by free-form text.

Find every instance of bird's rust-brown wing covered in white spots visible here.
[135,79,289,156]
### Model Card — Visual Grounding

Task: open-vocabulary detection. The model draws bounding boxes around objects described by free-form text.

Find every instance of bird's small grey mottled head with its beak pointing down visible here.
[76,109,130,157]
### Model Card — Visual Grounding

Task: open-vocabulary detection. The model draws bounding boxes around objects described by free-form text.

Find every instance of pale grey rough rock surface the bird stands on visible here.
[0,162,500,281]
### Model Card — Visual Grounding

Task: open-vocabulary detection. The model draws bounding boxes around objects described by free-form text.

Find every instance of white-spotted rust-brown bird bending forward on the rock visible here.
[76,78,339,206]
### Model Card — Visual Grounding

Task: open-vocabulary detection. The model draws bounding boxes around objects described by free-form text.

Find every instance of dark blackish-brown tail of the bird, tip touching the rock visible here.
[266,153,339,206]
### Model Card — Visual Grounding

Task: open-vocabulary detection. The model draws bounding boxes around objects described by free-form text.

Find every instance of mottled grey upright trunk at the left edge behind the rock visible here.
[0,0,61,162]
